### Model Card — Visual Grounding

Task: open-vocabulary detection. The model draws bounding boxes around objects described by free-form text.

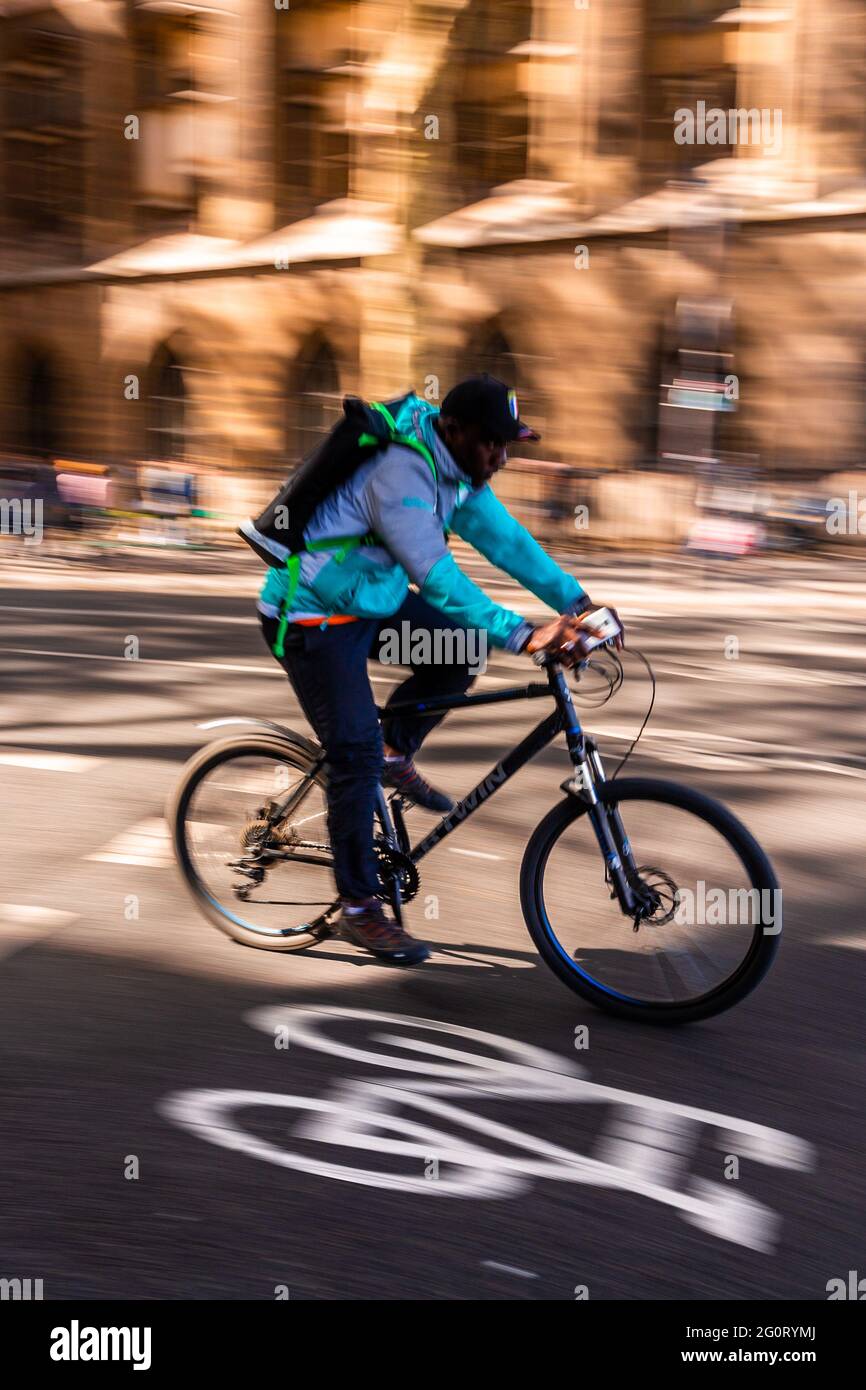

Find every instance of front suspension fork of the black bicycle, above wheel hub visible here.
[548,666,641,917]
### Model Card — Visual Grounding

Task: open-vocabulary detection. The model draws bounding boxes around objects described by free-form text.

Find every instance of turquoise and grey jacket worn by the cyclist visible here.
[259,396,589,652]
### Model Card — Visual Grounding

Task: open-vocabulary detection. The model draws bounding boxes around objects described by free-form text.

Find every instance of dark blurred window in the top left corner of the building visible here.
[0,14,86,240]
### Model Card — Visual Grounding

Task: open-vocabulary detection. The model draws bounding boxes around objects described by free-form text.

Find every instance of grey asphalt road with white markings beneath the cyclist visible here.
[0,539,866,1300]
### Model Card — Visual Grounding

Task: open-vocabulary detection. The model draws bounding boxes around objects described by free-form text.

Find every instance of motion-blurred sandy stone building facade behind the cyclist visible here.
[0,0,866,500]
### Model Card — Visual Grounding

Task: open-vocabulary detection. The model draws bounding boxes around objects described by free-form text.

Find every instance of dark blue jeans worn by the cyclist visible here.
[261,594,475,898]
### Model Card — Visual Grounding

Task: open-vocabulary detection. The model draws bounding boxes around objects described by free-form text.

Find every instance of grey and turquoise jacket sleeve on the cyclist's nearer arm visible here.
[367,446,532,652]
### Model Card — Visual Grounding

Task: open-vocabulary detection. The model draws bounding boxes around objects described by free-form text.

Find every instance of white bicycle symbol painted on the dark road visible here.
[158,1006,813,1252]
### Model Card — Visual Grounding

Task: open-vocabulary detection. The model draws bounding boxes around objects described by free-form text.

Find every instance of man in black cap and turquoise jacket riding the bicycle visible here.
[259,374,622,965]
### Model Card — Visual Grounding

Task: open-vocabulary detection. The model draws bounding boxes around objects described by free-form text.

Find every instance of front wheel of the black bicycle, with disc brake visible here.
[520,777,781,1023]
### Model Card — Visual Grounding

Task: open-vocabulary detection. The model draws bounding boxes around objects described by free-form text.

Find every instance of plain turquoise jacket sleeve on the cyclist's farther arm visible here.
[450,484,592,613]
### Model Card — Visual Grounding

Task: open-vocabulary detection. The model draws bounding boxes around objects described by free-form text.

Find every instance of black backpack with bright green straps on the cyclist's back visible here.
[238,392,436,656]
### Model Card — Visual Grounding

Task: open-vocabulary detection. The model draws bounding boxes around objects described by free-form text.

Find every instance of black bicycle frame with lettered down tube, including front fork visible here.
[378,660,644,919]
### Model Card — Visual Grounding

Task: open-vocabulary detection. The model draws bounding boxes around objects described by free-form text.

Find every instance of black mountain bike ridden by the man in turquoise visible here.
[170,657,781,1023]
